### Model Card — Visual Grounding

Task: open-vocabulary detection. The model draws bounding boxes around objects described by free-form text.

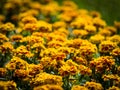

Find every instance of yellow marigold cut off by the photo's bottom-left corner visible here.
[0,81,18,90]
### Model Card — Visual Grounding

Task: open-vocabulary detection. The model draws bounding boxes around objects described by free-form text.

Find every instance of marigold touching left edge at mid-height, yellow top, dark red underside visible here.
[0,42,14,54]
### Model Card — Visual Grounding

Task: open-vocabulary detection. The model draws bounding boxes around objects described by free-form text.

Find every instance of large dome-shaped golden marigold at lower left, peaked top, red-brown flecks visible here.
[5,56,28,70]
